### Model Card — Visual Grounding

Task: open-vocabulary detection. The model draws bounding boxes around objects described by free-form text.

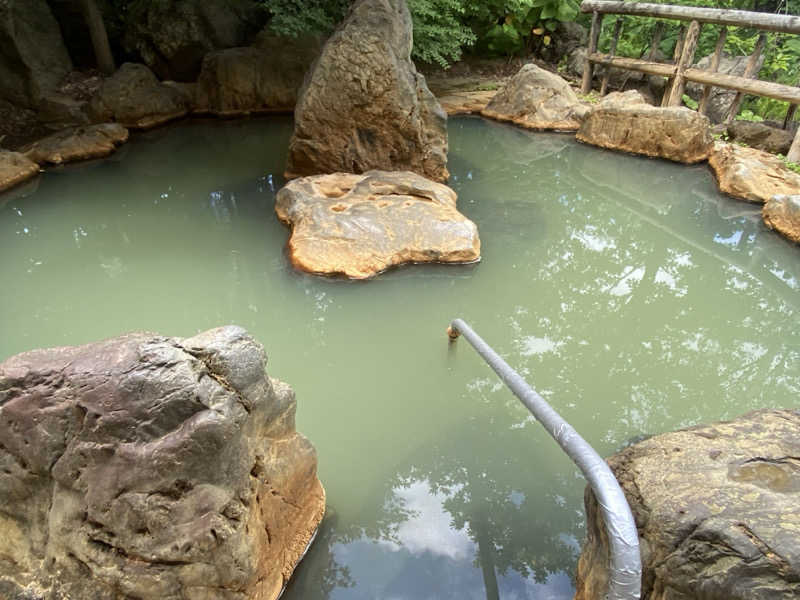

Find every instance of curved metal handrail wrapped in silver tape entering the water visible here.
[447,319,642,600]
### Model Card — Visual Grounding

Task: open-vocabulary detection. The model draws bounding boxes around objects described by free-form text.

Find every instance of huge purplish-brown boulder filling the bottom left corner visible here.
[0,327,324,600]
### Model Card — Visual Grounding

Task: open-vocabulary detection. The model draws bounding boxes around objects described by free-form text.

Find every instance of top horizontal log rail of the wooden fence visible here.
[581,0,800,33]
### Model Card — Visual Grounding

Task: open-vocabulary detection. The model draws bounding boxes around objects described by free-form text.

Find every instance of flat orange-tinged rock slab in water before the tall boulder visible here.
[275,171,480,279]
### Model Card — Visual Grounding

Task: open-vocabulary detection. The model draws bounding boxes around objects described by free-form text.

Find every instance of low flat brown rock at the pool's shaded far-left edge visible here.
[22,123,128,165]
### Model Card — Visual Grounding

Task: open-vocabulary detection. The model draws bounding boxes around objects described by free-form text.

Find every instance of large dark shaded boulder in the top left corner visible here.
[0,0,72,108]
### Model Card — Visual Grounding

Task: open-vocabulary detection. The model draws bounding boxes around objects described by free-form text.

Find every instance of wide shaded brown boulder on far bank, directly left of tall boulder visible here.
[196,35,322,116]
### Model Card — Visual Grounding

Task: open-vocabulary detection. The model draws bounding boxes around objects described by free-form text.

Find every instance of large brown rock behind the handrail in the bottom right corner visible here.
[575,410,800,600]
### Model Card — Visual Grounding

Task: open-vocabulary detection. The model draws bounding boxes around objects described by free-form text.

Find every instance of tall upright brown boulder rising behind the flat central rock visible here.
[286,0,448,181]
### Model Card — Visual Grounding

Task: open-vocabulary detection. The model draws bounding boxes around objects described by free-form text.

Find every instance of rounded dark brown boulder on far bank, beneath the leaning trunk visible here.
[90,63,190,129]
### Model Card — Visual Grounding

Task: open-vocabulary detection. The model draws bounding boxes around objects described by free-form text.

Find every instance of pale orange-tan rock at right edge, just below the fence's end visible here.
[708,142,800,202]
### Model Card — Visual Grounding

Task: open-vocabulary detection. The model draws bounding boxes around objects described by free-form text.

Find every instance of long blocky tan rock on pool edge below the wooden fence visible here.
[577,103,713,164]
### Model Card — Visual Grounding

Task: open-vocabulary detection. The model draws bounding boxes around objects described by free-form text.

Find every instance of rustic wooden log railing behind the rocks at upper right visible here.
[581,0,800,162]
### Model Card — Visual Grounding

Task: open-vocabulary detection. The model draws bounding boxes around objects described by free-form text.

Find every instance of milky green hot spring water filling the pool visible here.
[0,118,800,600]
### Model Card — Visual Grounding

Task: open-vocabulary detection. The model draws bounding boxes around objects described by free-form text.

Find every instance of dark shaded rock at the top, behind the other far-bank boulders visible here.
[123,0,267,81]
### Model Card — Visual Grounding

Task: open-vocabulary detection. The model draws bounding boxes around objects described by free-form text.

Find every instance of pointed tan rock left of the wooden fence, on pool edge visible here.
[481,63,581,131]
